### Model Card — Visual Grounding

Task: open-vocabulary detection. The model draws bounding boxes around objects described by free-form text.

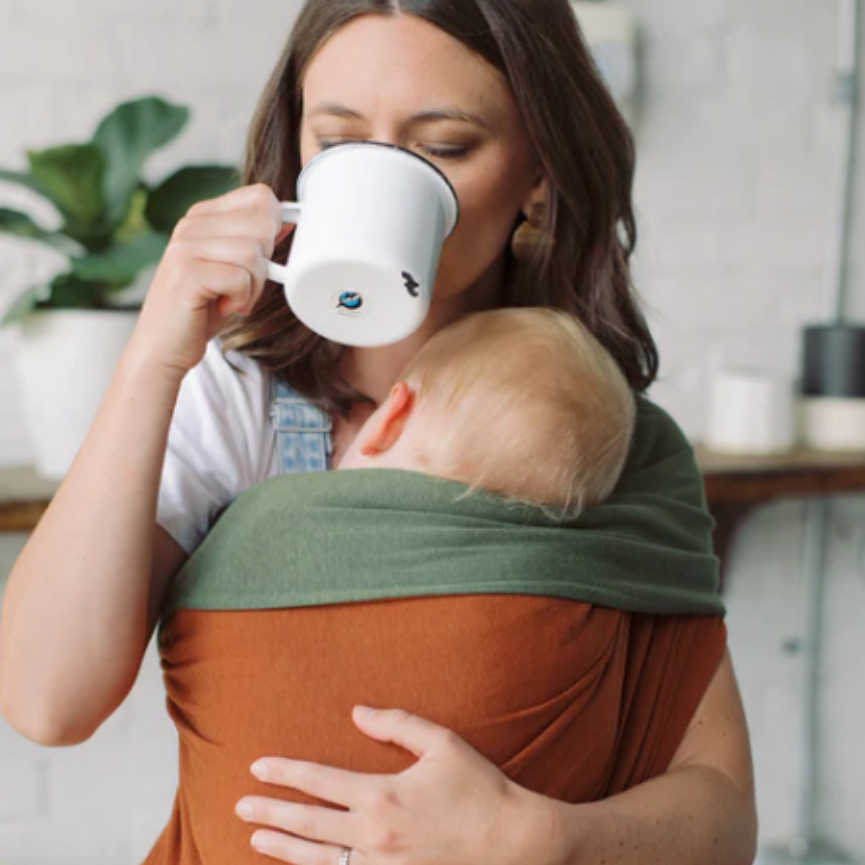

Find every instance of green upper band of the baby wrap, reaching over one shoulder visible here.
[164,399,724,620]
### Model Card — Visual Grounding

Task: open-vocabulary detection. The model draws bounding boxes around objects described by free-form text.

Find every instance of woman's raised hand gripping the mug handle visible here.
[130,184,291,375]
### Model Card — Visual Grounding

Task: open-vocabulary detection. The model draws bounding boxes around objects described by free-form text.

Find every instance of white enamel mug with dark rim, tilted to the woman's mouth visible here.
[267,141,459,347]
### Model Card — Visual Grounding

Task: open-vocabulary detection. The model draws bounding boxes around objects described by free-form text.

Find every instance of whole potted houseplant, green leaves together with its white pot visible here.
[0,96,239,479]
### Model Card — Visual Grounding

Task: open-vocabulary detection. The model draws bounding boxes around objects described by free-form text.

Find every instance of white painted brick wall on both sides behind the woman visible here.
[0,0,865,865]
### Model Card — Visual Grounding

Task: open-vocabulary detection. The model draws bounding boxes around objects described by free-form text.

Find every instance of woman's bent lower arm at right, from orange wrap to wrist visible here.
[526,654,757,865]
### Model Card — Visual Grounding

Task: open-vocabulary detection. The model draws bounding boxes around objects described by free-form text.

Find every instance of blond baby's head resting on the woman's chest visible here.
[340,308,635,511]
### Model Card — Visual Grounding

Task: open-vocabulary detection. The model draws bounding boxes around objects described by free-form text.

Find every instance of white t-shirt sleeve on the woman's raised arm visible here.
[156,340,278,554]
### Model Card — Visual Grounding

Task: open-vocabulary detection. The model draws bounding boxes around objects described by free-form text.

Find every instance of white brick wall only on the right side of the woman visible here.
[626,0,865,861]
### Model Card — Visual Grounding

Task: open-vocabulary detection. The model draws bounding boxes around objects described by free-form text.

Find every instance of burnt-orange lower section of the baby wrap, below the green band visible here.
[146,595,726,865]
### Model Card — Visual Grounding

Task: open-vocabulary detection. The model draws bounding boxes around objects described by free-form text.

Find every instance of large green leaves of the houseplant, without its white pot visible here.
[0,96,239,324]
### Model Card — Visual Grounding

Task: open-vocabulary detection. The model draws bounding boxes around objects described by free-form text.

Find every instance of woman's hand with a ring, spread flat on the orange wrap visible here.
[237,707,556,865]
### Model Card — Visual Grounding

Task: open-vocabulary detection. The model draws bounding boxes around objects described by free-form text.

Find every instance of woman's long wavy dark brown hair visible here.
[223,0,658,414]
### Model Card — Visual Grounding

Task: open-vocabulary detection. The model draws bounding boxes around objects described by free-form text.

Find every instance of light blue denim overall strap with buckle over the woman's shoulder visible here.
[270,377,333,475]
